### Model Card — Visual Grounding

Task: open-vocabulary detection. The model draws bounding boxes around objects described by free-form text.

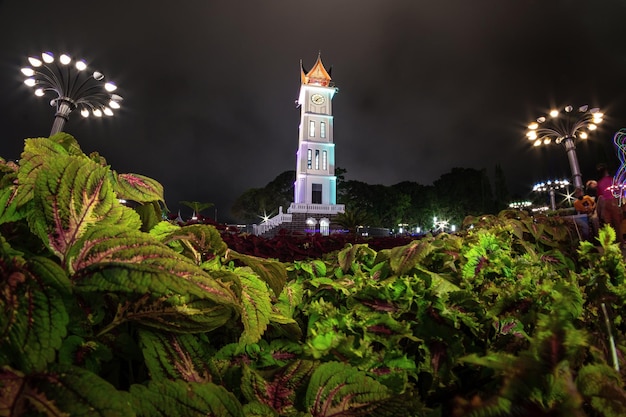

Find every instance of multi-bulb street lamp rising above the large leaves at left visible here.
[22,52,122,136]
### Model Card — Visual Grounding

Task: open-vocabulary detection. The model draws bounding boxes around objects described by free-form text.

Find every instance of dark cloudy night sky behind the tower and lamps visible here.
[0,0,626,221]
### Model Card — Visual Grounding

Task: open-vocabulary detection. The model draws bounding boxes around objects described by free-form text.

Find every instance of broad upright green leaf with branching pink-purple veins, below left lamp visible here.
[29,156,141,262]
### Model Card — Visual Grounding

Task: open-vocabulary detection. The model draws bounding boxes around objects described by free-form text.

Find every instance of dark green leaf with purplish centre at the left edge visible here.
[0,257,69,371]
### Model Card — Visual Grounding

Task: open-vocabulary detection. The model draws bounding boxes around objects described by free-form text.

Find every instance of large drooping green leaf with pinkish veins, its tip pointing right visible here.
[70,226,240,332]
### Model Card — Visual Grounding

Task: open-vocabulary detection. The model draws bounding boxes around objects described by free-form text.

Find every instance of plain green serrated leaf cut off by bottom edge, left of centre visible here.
[130,379,244,417]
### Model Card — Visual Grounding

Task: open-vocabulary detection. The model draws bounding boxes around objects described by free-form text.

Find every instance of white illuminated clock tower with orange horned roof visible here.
[288,55,344,221]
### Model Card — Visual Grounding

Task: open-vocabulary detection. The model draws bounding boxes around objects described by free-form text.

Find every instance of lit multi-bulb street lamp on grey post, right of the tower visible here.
[526,104,604,188]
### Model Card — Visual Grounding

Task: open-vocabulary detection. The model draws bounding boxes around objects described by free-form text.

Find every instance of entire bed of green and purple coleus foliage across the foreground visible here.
[0,133,626,417]
